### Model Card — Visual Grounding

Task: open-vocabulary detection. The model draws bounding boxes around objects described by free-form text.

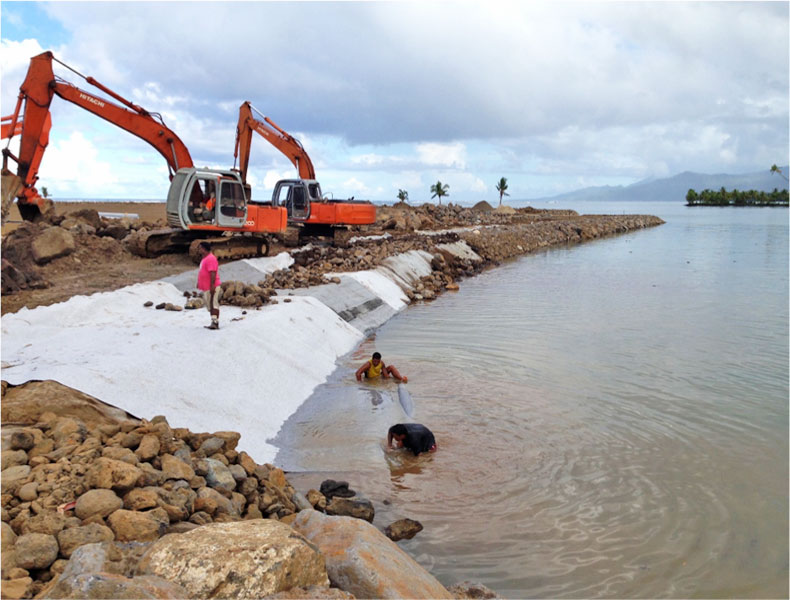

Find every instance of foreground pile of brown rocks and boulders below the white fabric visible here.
[0,381,502,598]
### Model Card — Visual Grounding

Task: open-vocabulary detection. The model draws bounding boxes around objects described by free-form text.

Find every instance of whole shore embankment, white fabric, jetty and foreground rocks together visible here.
[2,209,663,598]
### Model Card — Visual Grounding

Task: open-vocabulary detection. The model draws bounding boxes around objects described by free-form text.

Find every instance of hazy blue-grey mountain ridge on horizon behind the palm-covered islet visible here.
[531,166,790,202]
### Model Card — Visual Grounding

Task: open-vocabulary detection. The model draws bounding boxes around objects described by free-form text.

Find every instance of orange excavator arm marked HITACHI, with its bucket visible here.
[3,52,193,220]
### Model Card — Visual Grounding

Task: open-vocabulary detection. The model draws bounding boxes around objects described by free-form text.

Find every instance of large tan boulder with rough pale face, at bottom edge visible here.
[137,519,329,598]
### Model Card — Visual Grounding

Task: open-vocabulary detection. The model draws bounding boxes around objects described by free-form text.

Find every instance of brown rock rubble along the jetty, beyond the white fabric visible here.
[207,205,663,307]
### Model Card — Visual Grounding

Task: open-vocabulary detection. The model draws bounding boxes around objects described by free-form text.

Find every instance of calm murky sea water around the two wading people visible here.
[274,203,788,598]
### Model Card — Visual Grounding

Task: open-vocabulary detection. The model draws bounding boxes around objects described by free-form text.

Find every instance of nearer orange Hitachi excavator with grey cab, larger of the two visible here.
[3,52,287,258]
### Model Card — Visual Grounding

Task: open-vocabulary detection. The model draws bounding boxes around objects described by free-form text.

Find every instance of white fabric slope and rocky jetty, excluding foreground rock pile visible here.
[2,215,663,462]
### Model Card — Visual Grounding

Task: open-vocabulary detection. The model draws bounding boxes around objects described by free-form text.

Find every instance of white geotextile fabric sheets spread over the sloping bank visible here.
[2,245,476,463]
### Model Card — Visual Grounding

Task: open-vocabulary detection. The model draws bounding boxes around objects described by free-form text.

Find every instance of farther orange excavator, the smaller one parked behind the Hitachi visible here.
[233,102,376,240]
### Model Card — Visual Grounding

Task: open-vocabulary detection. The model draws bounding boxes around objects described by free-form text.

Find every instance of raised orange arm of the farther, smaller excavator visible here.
[233,102,315,183]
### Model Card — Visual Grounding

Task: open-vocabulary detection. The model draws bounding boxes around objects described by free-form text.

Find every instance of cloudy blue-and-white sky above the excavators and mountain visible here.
[0,0,790,203]
